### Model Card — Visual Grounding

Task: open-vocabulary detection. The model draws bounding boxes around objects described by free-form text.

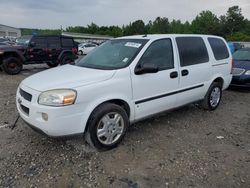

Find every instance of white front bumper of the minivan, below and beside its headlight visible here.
[16,85,86,137]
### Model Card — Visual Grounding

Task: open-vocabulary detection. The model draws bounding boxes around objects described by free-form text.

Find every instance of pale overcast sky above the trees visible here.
[0,0,250,29]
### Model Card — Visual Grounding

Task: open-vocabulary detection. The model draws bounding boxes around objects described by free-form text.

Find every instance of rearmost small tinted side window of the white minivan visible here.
[208,37,229,60]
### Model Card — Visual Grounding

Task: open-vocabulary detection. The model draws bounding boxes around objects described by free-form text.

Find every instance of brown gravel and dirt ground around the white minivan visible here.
[0,66,250,188]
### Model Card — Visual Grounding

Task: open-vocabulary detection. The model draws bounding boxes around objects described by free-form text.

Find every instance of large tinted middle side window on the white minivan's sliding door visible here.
[176,37,209,67]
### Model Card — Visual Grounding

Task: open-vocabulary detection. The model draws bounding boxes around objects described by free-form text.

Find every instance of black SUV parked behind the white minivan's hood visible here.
[0,35,77,75]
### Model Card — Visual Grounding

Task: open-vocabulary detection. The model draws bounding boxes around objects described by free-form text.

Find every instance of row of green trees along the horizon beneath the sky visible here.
[21,6,250,42]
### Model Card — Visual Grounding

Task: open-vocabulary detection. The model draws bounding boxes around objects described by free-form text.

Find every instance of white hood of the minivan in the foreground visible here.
[22,65,116,91]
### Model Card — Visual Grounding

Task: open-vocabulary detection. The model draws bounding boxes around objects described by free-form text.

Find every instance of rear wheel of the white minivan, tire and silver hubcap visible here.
[202,82,222,111]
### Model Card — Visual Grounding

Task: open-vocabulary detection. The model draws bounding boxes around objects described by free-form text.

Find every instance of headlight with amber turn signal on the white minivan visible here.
[38,89,76,106]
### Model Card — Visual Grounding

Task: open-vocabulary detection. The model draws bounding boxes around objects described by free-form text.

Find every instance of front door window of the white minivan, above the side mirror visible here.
[139,39,174,70]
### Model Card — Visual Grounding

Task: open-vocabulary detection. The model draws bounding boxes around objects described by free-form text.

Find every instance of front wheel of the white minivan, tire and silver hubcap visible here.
[86,103,129,151]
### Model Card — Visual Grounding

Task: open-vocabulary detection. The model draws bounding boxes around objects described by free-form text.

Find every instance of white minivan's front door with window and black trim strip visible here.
[131,38,179,119]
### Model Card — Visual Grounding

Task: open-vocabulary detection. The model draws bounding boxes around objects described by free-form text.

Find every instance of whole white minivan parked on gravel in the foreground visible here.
[16,35,232,150]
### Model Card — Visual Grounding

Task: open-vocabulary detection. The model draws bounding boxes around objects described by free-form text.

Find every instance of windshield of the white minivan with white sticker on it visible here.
[76,39,148,70]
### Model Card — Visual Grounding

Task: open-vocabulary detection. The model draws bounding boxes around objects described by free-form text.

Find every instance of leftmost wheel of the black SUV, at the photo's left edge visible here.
[2,57,23,75]
